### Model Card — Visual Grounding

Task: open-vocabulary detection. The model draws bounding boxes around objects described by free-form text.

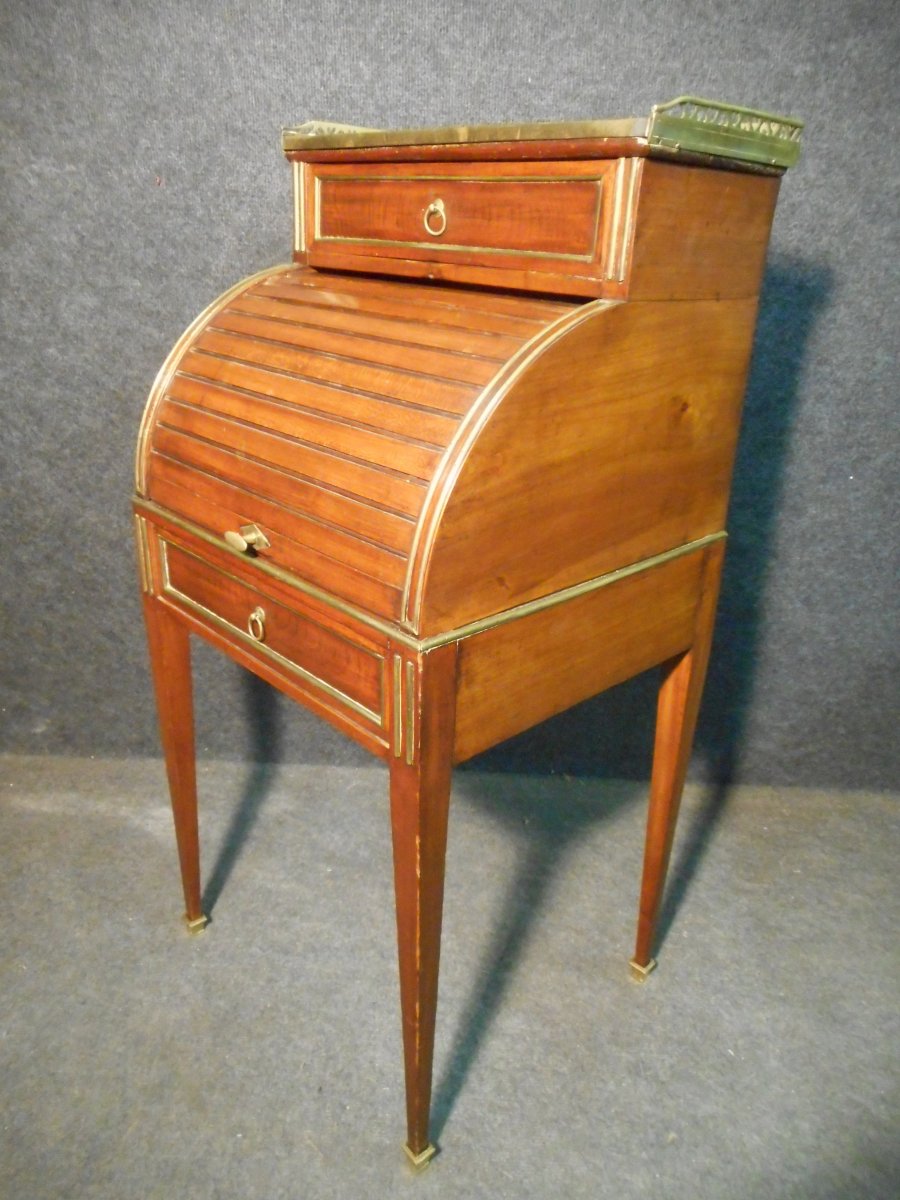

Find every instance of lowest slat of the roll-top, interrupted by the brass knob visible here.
[150,470,401,616]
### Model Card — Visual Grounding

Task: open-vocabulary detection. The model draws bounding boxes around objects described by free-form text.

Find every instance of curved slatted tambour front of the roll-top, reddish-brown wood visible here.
[139,268,572,618]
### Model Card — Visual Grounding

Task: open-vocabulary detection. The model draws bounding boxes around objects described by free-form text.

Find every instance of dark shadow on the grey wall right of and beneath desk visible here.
[462,258,832,782]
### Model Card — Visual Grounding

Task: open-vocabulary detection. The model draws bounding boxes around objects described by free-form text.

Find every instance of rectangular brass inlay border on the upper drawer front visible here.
[314,174,604,263]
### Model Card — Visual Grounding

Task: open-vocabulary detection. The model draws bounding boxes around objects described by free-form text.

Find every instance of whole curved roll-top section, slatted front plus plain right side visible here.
[137,224,772,636]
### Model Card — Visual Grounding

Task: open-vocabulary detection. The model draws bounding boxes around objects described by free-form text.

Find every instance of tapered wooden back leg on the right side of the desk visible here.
[631,541,725,980]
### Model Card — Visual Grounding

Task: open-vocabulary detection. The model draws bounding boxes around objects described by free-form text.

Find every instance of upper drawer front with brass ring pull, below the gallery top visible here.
[305,162,616,295]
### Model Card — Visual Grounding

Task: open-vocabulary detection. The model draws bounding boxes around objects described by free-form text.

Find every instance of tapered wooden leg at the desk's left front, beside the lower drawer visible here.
[144,596,206,930]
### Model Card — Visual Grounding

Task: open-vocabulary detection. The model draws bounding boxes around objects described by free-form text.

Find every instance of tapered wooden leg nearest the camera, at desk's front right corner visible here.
[390,646,456,1166]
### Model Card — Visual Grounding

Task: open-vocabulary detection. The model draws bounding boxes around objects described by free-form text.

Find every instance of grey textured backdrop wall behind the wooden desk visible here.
[0,0,900,787]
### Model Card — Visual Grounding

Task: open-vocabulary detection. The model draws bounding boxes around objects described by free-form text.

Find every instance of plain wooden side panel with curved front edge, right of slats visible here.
[409,299,756,636]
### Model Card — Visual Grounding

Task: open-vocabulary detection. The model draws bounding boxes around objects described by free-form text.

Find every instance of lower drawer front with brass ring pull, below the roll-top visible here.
[158,538,385,727]
